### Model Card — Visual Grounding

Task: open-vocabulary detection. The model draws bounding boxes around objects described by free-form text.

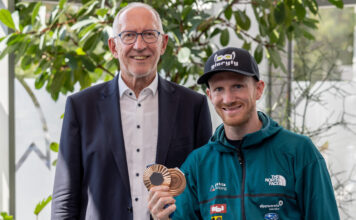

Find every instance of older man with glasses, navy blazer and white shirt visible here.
[52,3,211,220]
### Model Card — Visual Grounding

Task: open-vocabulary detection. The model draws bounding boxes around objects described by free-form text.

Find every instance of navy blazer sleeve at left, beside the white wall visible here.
[51,97,82,220]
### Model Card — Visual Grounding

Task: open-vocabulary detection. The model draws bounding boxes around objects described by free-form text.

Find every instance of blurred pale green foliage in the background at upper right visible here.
[294,7,356,82]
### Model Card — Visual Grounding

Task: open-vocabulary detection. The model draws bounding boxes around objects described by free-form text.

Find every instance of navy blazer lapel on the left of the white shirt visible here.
[99,75,130,192]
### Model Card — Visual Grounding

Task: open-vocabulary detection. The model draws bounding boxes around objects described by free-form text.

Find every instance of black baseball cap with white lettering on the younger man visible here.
[198,47,260,84]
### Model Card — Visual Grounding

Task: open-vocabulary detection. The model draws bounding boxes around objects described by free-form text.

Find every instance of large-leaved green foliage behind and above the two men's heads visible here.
[0,0,343,100]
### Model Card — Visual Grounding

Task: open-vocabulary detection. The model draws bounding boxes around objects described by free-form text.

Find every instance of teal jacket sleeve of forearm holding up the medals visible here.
[172,155,203,220]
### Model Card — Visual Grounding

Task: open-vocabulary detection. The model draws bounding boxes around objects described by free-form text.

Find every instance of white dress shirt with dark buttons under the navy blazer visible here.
[118,73,158,220]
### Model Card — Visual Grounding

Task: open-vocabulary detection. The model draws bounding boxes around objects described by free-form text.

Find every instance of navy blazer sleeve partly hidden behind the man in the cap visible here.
[195,96,212,148]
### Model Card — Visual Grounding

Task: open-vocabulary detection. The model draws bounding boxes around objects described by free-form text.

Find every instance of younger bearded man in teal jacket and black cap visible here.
[148,47,339,220]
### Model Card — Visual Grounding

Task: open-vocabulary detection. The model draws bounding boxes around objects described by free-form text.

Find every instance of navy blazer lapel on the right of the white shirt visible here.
[156,77,179,164]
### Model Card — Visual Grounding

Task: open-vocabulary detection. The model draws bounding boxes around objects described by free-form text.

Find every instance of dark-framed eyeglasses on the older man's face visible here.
[118,30,161,44]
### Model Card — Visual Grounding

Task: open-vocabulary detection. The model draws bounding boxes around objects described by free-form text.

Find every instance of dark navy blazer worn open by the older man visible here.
[51,76,212,220]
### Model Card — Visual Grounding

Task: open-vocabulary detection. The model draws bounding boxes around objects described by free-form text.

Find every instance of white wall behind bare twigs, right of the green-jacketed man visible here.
[293,81,356,219]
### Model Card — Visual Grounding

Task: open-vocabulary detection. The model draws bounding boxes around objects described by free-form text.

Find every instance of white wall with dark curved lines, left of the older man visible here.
[15,79,69,220]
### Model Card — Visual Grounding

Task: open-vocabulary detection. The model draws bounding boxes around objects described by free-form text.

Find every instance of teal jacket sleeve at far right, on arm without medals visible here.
[296,145,340,220]
